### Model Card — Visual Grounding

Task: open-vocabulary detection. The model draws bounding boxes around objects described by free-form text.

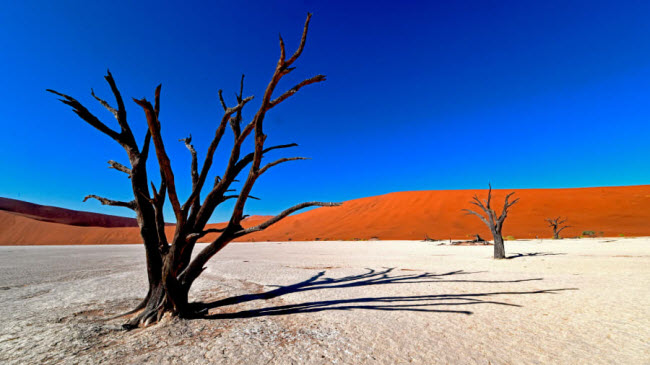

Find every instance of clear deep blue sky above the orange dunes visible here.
[0,1,650,221]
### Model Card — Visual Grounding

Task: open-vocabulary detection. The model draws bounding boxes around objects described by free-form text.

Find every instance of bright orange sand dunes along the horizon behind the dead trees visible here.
[0,185,650,245]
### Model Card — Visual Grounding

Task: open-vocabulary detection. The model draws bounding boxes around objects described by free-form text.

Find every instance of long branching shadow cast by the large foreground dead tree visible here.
[192,268,577,319]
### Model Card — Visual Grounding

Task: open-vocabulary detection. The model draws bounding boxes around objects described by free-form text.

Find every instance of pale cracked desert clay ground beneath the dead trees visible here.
[0,237,650,364]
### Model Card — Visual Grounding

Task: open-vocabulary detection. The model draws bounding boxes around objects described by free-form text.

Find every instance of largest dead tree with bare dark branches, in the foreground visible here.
[48,14,339,328]
